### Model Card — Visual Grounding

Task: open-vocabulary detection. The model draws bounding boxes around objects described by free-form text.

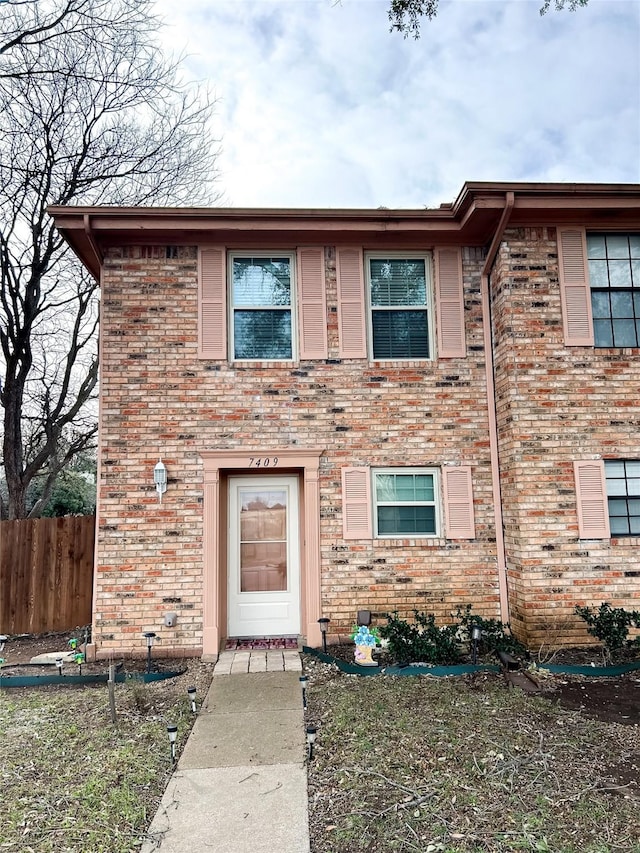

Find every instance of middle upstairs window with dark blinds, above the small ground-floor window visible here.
[366,254,431,360]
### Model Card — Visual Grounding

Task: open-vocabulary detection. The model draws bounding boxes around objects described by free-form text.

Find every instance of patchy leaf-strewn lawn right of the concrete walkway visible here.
[307,661,640,853]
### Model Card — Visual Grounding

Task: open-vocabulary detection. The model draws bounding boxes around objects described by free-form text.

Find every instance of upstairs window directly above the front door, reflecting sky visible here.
[230,253,295,361]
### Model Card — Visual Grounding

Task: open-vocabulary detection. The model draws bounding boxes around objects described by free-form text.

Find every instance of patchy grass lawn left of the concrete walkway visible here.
[0,661,211,853]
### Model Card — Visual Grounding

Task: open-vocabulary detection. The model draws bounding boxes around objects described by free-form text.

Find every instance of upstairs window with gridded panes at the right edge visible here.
[587,234,640,347]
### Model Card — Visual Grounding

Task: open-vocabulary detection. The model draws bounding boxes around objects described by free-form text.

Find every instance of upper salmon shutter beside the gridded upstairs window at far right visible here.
[558,228,593,347]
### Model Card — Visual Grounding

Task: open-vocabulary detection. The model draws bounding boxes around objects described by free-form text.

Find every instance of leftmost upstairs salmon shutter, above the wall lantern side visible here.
[198,247,227,358]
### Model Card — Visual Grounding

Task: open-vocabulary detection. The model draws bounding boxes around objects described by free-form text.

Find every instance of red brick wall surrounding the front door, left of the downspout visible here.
[94,247,499,653]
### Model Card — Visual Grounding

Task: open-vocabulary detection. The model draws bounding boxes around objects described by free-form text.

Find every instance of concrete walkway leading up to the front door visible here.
[142,651,309,853]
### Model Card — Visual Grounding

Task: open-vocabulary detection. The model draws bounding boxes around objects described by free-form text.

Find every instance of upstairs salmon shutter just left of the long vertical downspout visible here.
[435,248,467,358]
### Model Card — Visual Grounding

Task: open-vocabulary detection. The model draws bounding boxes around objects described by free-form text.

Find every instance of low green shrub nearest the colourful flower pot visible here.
[380,610,460,664]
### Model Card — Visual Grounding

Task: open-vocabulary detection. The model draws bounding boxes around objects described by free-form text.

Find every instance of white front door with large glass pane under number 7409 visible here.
[228,477,300,637]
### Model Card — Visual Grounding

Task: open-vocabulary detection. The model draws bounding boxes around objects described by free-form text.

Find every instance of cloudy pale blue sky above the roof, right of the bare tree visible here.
[157,0,640,208]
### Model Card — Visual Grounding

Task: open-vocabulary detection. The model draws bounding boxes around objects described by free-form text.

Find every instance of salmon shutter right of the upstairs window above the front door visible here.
[298,248,327,358]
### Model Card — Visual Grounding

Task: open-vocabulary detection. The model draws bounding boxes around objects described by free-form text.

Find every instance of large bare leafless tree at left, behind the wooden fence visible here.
[0,0,217,518]
